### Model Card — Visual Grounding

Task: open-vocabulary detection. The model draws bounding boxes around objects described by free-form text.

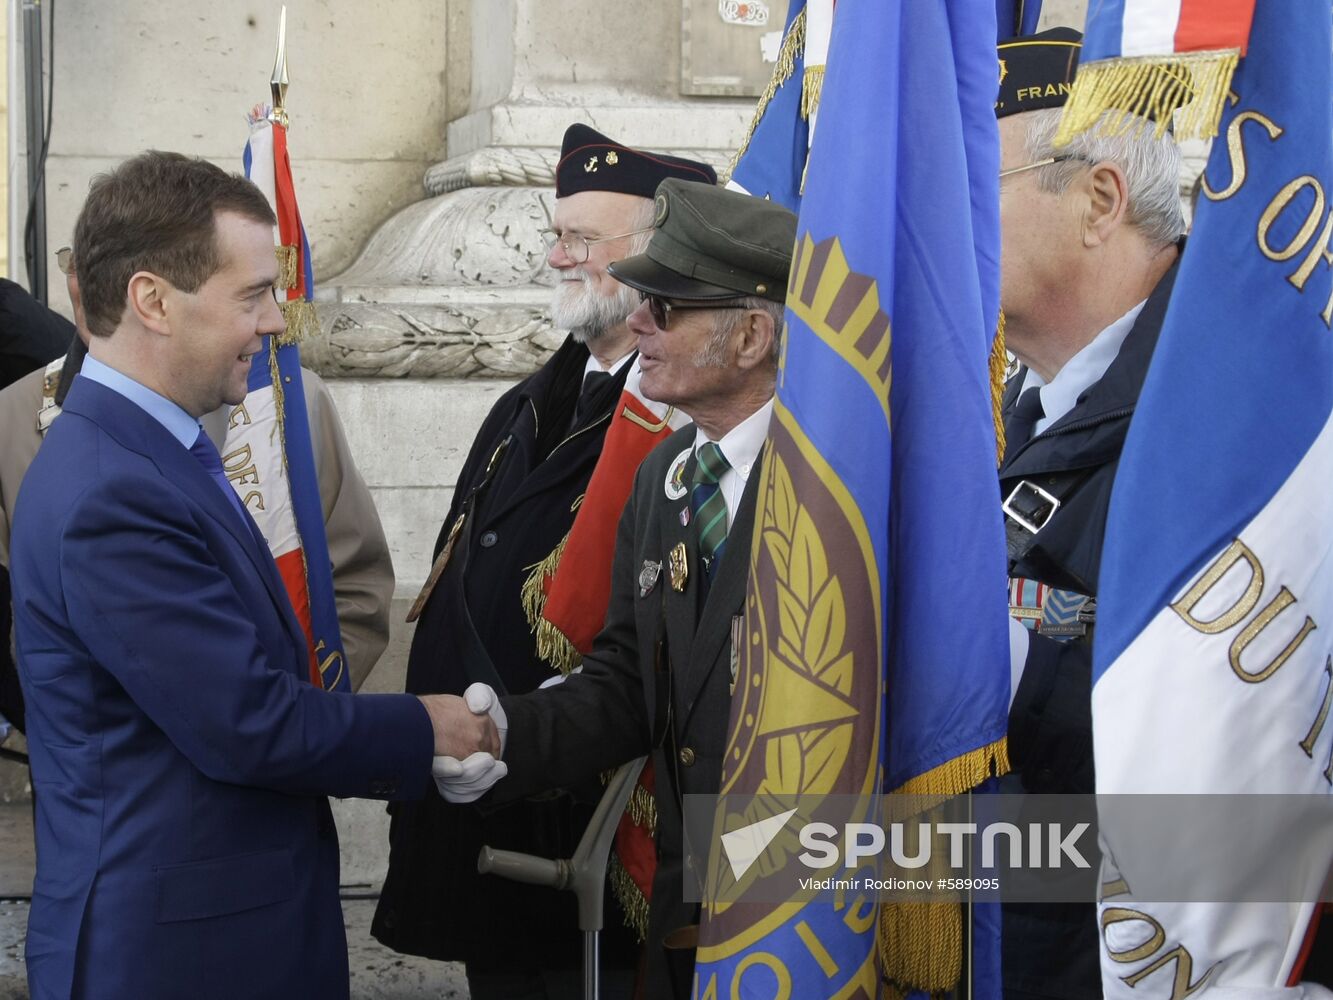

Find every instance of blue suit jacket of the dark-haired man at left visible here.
[12,377,432,1000]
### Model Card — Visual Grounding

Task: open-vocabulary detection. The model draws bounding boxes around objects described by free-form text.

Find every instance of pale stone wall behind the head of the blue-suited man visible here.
[9,0,453,305]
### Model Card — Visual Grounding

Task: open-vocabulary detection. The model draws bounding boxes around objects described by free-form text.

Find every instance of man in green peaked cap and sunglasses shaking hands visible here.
[431,179,796,1000]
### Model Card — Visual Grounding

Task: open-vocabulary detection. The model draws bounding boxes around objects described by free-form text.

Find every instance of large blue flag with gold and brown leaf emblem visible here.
[696,0,1009,997]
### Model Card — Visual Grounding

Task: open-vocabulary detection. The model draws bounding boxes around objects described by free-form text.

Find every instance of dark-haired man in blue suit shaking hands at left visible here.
[12,152,499,997]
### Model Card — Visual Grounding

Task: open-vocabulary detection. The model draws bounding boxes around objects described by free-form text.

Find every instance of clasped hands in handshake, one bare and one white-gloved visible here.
[421,684,509,803]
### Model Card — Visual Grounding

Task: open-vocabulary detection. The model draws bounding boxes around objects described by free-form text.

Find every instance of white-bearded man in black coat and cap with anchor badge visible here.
[372,124,717,1000]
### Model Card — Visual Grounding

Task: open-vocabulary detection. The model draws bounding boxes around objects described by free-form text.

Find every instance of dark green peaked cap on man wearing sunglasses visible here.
[609,177,796,303]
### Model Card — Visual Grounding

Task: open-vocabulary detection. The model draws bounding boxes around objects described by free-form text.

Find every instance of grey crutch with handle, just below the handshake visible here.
[477,757,648,1000]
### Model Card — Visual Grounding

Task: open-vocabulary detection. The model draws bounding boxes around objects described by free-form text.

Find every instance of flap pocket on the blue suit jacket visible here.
[153,848,296,924]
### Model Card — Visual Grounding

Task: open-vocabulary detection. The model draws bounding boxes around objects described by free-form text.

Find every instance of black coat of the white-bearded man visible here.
[371,339,635,971]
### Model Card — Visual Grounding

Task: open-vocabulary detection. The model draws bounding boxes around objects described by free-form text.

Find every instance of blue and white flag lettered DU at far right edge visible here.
[1080,0,1333,1000]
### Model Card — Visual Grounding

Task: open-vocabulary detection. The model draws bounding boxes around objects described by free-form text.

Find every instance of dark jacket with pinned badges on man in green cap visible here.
[493,425,761,999]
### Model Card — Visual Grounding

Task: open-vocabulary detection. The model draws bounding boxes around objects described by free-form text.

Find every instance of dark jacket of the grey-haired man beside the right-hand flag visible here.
[1000,264,1178,997]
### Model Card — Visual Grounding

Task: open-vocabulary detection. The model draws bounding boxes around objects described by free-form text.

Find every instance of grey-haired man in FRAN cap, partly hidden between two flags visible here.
[996,28,1185,997]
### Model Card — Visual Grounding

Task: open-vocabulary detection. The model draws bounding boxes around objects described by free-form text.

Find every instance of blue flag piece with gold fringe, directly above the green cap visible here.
[730,0,810,212]
